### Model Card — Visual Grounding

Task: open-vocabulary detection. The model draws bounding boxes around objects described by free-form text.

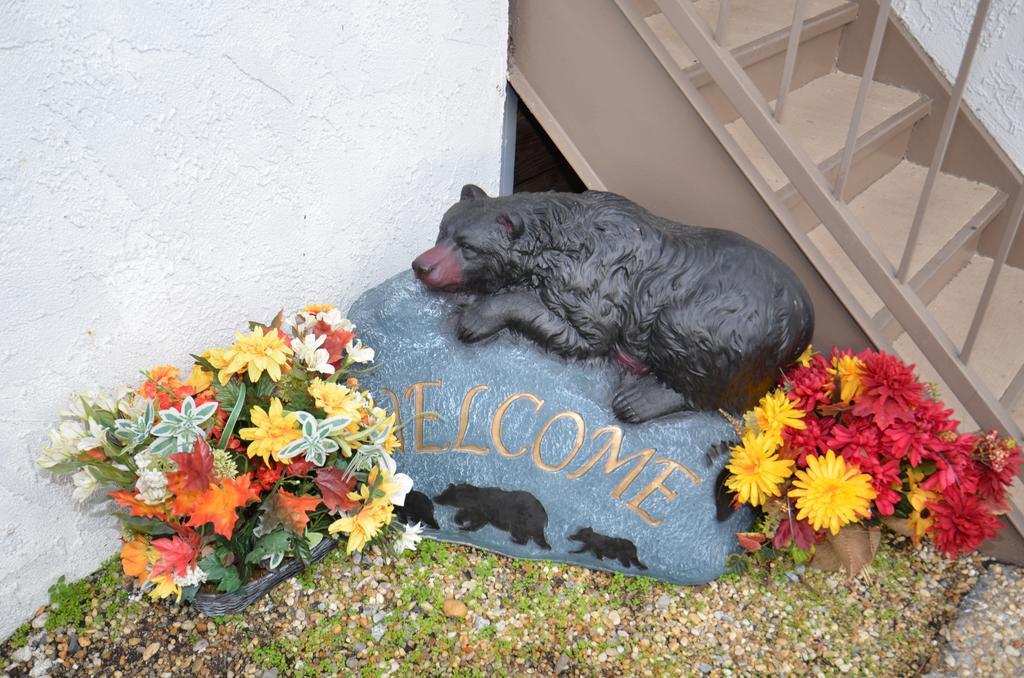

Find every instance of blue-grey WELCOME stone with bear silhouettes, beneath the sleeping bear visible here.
[349,272,752,584]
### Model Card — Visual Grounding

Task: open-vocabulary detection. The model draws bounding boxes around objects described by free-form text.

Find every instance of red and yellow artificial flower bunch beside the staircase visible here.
[725,348,1021,574]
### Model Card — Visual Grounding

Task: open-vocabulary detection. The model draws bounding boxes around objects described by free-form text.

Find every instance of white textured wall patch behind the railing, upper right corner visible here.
[893,0,1024,171]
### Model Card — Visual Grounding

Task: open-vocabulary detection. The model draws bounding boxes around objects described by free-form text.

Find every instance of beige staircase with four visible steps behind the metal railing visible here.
[637,0,1024,436]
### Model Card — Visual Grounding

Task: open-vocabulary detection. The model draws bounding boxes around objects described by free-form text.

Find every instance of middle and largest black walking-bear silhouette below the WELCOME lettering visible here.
[434,482,551,549]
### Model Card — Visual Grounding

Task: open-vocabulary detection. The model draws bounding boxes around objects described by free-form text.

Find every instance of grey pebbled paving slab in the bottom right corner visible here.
[928,563,1024,678]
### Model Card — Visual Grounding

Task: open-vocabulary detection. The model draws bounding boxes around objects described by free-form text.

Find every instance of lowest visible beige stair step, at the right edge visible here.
[894,254,1024,425]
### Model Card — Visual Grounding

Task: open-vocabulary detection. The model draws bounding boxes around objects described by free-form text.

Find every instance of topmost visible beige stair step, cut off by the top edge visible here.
[646,0,857,72]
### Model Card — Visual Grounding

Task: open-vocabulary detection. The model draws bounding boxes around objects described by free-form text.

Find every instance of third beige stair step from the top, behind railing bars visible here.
[810,160,1006,315]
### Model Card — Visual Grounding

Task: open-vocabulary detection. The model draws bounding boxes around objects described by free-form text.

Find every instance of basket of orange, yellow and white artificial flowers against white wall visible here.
[39,305,420,601]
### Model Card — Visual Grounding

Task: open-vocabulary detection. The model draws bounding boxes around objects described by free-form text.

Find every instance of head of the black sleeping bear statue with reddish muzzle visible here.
[413,183,523,292]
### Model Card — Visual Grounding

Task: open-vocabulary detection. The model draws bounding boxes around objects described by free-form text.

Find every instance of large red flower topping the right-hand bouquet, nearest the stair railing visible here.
[853,351,925,429]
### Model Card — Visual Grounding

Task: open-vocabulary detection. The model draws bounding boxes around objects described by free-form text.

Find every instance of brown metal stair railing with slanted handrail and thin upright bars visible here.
[616,0,1024,531]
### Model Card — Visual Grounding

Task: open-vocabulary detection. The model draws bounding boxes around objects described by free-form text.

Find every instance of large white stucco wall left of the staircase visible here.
[0,0,508,638]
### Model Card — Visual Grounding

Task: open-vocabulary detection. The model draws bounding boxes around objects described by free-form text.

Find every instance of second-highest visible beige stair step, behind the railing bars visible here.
[726,71,924,190]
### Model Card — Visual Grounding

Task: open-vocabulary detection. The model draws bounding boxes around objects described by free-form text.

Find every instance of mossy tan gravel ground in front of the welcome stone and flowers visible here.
[0,536,991,678]
